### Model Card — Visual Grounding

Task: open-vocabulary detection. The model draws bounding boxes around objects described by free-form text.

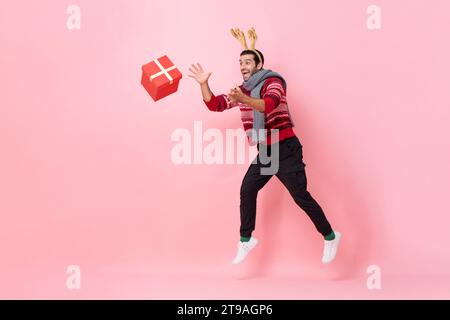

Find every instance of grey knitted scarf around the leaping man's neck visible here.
[242,69,286,143]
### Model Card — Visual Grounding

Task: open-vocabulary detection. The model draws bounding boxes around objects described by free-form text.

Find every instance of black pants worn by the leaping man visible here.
[240,136,332,237]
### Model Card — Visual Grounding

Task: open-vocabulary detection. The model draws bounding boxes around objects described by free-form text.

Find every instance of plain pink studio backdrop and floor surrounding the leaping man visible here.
[0,0,450,299]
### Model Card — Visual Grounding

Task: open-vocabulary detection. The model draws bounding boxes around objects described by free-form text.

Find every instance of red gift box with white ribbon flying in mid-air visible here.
[141,56,183,101]
